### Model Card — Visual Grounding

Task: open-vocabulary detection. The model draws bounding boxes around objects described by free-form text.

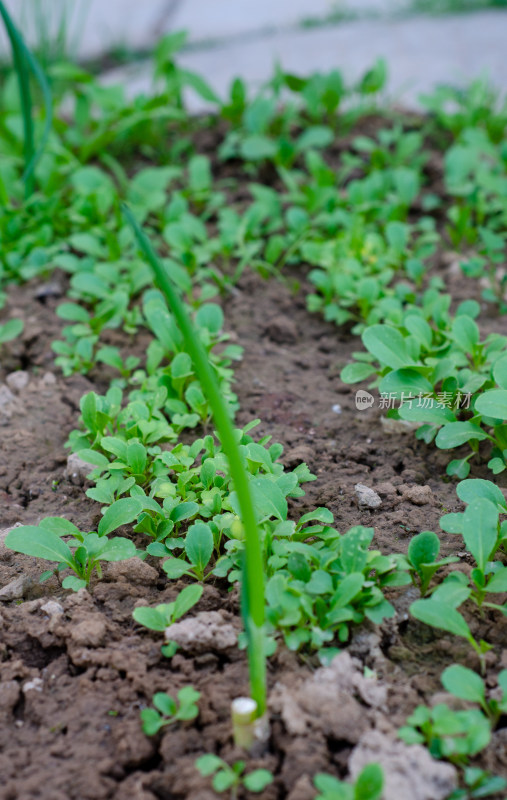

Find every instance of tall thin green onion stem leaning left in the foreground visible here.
[122,205,266,716]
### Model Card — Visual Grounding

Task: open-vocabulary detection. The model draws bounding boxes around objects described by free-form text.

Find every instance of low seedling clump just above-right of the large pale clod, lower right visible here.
[398,703,491,766]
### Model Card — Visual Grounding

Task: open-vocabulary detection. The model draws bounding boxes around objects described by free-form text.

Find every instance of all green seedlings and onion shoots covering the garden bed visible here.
[0,3,507,800]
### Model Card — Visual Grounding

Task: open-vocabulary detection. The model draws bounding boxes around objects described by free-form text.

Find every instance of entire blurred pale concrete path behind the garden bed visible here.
[0,0,507,110]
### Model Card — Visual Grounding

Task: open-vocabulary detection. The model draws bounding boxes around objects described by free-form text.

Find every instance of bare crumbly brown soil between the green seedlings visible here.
[0,122,507,800]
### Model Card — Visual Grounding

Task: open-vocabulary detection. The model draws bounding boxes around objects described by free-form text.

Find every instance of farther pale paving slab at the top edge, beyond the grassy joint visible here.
[0,0,411,59]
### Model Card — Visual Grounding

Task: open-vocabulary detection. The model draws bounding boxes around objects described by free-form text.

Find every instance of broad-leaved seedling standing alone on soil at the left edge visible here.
[5,516,137,592]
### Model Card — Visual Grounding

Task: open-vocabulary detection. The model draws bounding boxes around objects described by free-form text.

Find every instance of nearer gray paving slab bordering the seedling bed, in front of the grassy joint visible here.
[101,11,507,111]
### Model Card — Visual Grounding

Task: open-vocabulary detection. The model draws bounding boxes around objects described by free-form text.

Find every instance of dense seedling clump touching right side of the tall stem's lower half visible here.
[260,524,410,652]
